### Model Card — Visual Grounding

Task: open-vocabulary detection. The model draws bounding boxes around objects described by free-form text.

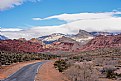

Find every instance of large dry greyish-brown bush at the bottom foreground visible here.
[65,62,98,81]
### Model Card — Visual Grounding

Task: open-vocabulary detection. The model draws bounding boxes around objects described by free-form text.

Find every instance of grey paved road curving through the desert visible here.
[2,62,44,81]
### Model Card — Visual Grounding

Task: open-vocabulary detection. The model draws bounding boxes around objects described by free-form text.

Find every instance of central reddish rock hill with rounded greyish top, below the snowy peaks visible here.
[39,36,81,52]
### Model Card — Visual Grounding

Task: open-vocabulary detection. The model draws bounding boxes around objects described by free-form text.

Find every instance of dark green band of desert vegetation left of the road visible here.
[0,51,57,66]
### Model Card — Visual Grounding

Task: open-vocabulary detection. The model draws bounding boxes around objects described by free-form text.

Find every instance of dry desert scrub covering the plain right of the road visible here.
[54,48,121,81]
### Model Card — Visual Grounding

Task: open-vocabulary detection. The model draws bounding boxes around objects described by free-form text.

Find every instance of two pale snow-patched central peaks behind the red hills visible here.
[38,30,93,44]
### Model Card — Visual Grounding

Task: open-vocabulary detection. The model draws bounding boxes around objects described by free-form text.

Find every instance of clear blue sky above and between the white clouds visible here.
[0,0,121,28]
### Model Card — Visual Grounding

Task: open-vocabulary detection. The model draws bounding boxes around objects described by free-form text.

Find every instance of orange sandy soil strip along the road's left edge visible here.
[0,60,40,79]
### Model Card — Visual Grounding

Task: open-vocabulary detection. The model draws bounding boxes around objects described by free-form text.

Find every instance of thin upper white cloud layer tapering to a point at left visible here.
[32,11,121,22]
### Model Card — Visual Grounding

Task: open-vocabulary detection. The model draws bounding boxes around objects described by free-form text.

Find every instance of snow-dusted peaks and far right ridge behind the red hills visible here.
[38,30,121,44]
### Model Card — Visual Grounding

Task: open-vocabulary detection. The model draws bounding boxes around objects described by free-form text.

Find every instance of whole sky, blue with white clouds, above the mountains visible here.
[0,0,121,39]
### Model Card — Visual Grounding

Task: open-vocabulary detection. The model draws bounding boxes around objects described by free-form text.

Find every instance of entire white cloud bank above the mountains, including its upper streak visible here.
[1,11,121,39]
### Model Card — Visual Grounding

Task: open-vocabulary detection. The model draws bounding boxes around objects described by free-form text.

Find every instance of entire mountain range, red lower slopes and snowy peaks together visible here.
[0,30,121,53]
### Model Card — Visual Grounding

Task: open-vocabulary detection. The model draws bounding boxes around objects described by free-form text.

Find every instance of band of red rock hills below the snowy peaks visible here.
[0,35,121,52]
